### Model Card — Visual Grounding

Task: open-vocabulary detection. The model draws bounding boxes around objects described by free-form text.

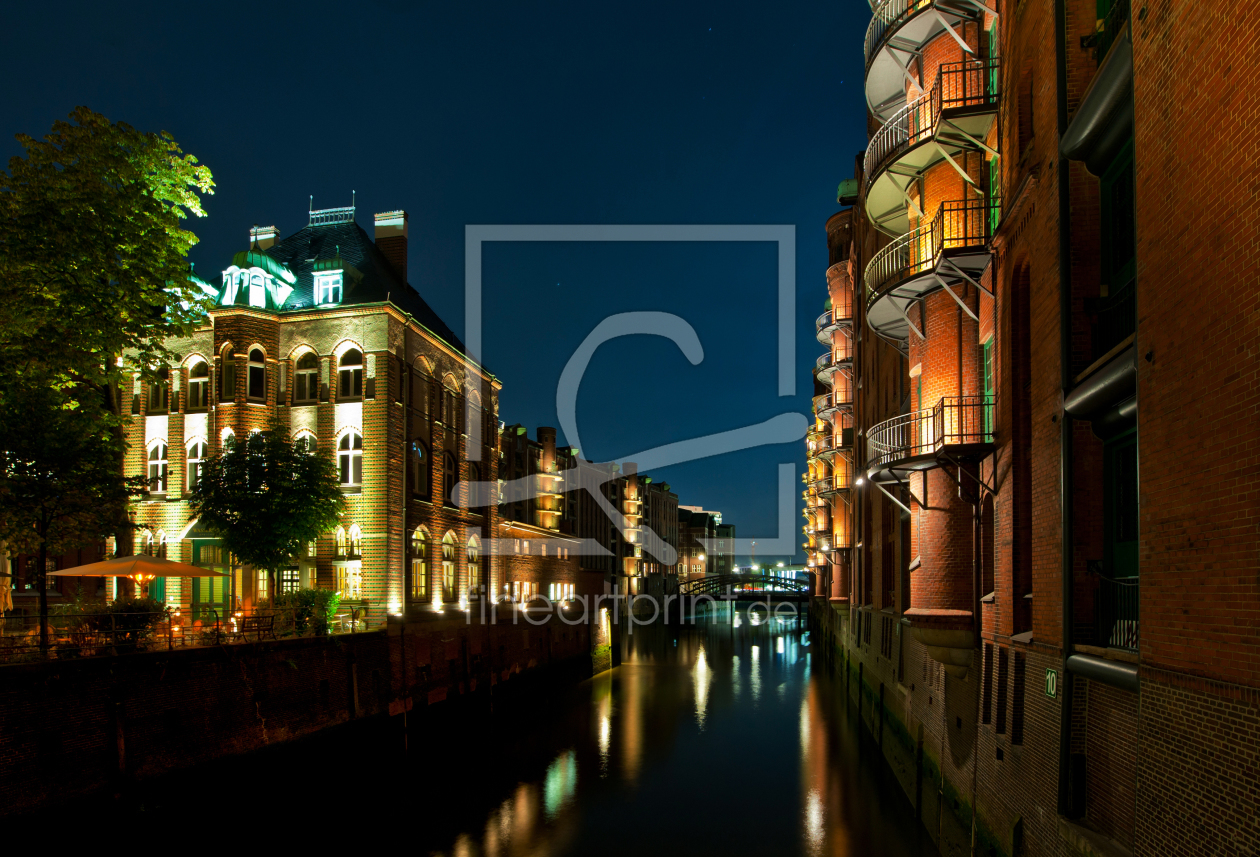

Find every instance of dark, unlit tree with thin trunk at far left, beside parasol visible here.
[0,377,145,652]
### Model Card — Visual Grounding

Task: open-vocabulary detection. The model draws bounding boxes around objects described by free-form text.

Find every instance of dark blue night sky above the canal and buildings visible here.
[7,0,869,562]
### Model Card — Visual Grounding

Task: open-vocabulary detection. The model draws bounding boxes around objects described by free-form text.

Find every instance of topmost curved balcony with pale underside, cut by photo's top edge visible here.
[866,0,985,120]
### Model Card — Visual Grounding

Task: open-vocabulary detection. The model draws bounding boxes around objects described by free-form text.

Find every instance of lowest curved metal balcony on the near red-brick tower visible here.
[867,396,993,483]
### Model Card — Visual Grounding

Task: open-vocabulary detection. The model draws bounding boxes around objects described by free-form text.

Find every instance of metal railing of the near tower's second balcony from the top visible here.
[863,59,998,187]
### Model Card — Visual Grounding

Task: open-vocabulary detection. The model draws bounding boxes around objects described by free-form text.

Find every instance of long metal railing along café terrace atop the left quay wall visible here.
[0,605,368,664]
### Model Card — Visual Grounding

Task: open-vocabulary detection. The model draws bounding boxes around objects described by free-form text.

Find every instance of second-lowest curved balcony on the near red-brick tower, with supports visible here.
[863,199,993,349]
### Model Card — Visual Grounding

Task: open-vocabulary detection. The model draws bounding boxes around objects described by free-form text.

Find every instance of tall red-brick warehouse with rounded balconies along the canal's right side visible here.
[805,0,1260,856]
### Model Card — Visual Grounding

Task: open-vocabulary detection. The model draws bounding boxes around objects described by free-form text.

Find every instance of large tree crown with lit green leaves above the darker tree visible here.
[0,107,214,405]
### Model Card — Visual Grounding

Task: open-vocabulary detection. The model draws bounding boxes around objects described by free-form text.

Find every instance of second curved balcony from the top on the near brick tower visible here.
[863,59,998,236]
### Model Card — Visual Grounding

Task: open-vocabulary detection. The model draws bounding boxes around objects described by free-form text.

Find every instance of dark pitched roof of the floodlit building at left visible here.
[251,222,464,353]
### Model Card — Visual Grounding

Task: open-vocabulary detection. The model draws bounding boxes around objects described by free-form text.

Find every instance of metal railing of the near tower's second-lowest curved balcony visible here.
[863,199,990,306]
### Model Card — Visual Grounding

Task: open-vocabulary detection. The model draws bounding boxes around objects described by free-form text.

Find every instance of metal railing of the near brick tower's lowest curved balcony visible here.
[867,396,993,469]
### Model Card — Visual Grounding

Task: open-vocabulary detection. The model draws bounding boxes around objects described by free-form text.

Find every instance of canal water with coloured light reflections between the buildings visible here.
[428,602,935,857]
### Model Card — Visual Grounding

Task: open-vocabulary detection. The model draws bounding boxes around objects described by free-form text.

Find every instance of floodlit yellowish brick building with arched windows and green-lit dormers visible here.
[120,207,500,618]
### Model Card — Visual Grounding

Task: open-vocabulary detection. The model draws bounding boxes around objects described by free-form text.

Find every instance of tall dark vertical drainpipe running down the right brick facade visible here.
[1055,0,1074,815]
